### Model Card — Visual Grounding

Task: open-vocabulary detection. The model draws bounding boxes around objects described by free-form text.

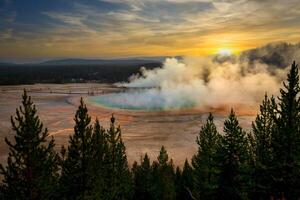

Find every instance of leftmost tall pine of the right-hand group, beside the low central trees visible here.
[192,113,221,199]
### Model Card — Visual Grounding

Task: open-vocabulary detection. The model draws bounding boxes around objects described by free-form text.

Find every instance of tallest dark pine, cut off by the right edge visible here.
[272,62,300,199]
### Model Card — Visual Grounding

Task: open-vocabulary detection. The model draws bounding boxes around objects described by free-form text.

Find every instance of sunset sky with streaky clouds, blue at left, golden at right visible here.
[0,0,300,60]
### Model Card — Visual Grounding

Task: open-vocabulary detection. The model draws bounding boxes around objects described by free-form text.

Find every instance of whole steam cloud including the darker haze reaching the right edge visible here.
[102,43,300,110]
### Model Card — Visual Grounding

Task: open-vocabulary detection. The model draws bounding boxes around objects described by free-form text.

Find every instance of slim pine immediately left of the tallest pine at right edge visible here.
[250,95,276,199]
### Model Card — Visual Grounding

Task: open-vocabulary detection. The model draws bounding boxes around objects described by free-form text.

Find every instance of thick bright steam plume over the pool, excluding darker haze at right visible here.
[119,57,286,109]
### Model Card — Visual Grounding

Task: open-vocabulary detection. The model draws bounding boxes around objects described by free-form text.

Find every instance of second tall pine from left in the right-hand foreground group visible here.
[218,110,250,200]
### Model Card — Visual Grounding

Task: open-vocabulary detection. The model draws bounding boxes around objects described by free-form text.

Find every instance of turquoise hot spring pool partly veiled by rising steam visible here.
[89,88,195,111]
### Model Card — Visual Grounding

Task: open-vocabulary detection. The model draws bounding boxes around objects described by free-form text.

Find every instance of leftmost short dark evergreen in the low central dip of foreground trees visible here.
[132,154,155,200]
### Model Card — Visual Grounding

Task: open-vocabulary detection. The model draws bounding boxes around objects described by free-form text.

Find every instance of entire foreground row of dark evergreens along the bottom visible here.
[0,62,300,200]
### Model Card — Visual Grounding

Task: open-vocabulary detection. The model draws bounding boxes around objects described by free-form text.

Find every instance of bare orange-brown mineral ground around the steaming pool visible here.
[0,84,256,165]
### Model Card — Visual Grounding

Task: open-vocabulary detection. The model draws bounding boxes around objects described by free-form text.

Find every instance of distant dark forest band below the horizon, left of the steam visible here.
[0,60,162,85]
